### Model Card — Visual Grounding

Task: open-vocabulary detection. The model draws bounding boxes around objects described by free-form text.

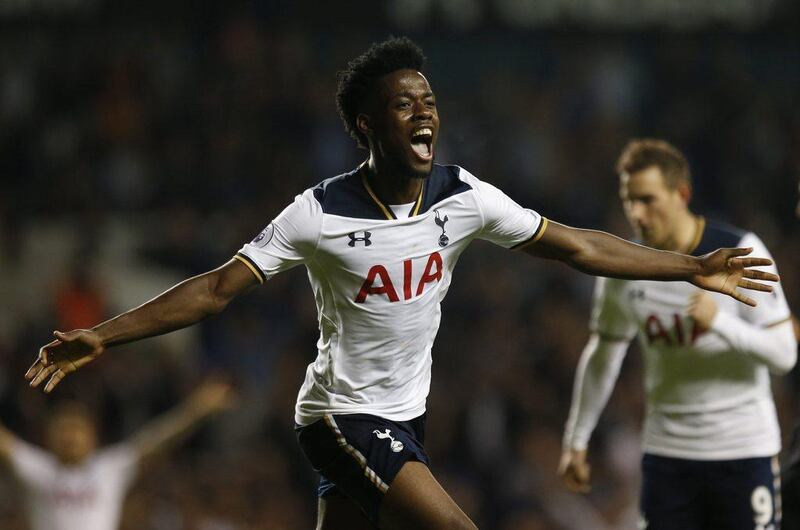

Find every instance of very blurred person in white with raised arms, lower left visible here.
[0,383,231,530]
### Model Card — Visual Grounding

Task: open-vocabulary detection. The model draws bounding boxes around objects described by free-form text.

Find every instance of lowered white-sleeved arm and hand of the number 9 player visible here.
[558,333,629,493]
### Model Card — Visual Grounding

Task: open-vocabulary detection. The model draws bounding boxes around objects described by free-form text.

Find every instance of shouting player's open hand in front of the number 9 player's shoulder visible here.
[691,248,780,307]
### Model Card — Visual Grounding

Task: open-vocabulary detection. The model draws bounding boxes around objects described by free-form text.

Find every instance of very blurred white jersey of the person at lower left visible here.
[10,440,139,530]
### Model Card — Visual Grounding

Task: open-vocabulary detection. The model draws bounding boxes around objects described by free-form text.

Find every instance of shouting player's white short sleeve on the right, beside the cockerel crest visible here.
[462,170,547,248]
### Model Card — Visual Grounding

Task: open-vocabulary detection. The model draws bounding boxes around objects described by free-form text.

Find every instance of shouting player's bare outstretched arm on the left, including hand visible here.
[25,259,258,392]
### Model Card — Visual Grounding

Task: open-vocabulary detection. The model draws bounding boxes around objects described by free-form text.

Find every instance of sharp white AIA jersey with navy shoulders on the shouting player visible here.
[237,165,547,425]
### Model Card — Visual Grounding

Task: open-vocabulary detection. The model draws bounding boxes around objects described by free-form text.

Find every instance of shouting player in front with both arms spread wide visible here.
[27,39,776,530]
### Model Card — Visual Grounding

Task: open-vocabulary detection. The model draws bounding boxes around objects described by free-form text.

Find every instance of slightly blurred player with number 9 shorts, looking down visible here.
[560,140,796,530]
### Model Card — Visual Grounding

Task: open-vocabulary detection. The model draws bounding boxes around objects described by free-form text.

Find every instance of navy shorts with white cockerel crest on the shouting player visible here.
[295,414,430,525]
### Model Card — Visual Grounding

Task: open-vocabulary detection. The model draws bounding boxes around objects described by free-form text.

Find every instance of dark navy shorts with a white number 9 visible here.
[640,454,781,530]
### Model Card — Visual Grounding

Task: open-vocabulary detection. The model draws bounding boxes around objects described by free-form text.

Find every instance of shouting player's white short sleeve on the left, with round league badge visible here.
[236,190,322,282]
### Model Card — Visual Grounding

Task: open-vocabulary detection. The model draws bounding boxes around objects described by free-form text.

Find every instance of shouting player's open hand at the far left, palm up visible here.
[25,329,105,393]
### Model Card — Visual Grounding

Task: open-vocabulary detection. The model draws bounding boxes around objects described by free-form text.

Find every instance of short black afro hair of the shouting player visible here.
[336,37,425,149]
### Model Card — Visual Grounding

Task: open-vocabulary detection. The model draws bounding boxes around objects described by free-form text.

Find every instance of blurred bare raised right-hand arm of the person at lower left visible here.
[131,381,234,459]
